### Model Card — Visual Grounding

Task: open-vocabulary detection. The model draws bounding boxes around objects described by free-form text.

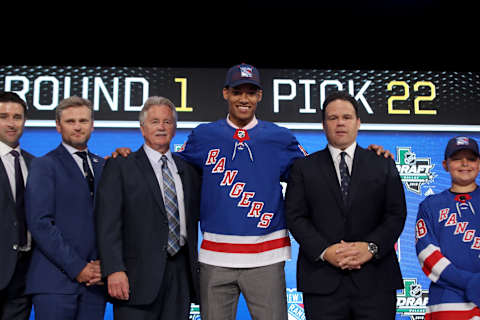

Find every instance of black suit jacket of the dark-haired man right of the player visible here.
[286,146,406,294]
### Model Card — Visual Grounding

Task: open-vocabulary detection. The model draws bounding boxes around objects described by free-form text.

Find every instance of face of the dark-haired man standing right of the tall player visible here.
[323,99,360,150]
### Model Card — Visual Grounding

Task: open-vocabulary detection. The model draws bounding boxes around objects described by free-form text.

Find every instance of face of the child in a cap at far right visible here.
[442,149,480,189]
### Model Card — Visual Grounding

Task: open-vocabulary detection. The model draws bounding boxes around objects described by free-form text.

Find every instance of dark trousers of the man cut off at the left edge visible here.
[0,252,32,320]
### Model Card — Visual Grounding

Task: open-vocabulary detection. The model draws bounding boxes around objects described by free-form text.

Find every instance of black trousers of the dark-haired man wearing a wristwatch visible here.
[303,276,397,320]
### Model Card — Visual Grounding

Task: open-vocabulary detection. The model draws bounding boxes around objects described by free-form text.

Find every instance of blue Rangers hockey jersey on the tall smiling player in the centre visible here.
[179,119,305,268]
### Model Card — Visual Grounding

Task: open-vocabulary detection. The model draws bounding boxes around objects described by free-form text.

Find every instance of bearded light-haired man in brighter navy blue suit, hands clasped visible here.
[26,97,106,320]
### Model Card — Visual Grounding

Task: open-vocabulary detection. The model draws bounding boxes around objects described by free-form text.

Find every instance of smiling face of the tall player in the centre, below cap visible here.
[223,84,262,128]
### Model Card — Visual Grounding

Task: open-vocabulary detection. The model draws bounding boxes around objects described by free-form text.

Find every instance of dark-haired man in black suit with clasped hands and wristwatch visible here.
[286,92,406,320]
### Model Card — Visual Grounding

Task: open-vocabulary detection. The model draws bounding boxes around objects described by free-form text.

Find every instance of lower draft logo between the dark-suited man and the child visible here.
[397,279,428,320]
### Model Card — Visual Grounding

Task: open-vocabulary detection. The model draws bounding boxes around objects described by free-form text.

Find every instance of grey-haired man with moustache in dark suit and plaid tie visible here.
[95,97,200,320]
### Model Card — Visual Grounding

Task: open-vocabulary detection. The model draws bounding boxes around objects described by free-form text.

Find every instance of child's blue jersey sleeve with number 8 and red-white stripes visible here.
[415,200,480,306]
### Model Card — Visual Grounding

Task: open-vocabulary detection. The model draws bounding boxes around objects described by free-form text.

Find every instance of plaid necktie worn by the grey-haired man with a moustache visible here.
[161,155,180,256]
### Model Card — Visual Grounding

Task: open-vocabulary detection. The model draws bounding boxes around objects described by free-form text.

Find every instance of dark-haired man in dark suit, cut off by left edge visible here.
[0,92,33,320]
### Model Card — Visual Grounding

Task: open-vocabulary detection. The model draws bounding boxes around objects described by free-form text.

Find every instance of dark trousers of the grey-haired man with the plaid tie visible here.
[113,246,192,320]
